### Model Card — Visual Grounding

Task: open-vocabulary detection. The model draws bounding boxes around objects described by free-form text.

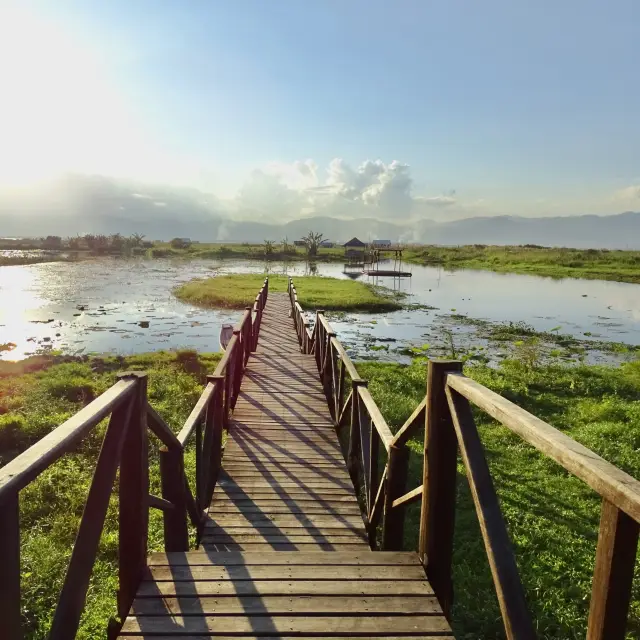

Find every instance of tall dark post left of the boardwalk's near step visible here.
[118,373,149,619]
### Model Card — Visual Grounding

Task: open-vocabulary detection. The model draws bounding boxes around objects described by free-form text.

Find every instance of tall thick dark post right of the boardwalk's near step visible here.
[418,360,462,618]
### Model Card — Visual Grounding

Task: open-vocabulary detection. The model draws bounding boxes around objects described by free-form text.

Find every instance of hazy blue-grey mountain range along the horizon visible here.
[0,207,640,249]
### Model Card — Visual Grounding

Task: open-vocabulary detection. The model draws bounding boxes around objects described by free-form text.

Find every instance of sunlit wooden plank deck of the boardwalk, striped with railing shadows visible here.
[121,294,452,640]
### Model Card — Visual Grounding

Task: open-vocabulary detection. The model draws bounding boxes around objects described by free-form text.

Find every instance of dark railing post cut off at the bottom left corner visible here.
[0,493,22,640]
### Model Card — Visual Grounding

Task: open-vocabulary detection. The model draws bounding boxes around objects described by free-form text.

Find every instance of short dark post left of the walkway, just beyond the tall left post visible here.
[160,447,189,552]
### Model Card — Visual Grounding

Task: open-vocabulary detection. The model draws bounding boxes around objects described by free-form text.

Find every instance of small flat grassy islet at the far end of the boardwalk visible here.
[174,274,402,312]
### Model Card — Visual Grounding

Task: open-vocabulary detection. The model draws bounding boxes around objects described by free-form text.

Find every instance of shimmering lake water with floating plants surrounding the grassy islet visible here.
[0,258,640,360]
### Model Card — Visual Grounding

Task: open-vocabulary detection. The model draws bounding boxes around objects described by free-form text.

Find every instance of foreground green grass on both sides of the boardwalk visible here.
[5,351,640,640]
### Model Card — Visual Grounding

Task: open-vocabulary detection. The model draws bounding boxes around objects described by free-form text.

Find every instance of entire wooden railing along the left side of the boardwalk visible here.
[0,279,269,640]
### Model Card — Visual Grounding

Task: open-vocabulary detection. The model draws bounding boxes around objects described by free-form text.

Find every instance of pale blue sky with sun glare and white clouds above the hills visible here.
[0,0,640,220]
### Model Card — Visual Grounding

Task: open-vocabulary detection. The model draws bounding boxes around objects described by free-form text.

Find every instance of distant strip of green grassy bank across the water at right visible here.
[405,245,640,283]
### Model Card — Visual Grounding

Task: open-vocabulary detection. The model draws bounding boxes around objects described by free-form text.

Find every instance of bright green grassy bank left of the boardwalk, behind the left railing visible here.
[0,351,219,640]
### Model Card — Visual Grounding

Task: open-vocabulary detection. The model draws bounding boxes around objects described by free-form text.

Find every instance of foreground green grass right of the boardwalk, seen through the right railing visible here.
[357,359,640,639]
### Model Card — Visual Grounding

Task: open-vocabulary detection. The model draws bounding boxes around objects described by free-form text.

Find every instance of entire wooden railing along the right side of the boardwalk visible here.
[288,279,640,640]
